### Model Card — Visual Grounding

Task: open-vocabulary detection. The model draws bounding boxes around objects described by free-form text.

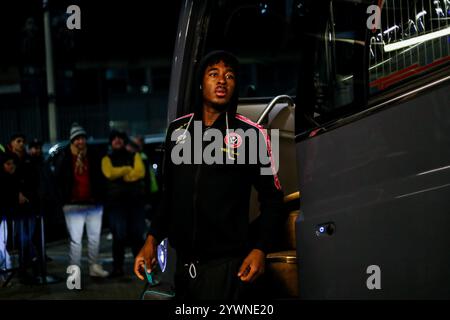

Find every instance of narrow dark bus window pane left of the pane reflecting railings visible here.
[313,2,364,115]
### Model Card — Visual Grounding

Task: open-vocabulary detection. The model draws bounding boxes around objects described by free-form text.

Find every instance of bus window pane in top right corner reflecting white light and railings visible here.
[369,0,450,94]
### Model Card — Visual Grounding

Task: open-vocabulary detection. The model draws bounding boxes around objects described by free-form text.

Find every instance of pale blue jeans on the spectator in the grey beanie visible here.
[63,205,103,267]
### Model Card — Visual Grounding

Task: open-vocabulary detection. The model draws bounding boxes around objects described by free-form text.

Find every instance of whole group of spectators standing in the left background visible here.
[0,123,158,286]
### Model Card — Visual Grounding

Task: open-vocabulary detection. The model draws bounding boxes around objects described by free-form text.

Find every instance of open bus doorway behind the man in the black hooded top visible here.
[169,0,302,297]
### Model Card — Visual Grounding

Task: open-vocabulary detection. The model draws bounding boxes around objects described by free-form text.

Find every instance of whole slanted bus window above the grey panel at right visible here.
[296,0,450,137]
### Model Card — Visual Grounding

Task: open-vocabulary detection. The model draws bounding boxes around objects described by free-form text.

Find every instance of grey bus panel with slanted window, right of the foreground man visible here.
[296,0,450,299]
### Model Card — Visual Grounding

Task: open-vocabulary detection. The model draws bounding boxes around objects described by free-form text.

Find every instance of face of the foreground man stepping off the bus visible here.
[202,61,236,110]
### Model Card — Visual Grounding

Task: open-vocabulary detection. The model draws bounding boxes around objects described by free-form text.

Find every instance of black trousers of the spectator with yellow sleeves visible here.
[107,203,145,270]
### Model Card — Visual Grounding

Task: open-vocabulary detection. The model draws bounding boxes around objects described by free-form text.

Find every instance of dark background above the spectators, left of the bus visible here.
[0,0,181,143]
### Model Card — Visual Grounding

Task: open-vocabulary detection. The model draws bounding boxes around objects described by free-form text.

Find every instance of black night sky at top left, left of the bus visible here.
[0,0,181,66]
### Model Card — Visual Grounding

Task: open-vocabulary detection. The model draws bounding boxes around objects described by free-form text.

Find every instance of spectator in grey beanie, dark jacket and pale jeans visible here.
[55,123,109,278]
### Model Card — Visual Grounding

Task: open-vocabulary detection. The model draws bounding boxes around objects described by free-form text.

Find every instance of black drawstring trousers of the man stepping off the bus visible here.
[175,257,261,301]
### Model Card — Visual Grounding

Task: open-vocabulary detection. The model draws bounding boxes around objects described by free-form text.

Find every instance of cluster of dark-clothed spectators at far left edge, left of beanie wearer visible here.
[0,133,44,280]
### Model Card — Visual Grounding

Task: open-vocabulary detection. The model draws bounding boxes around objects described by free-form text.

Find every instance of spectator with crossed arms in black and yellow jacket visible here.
[102,130,145,277]
